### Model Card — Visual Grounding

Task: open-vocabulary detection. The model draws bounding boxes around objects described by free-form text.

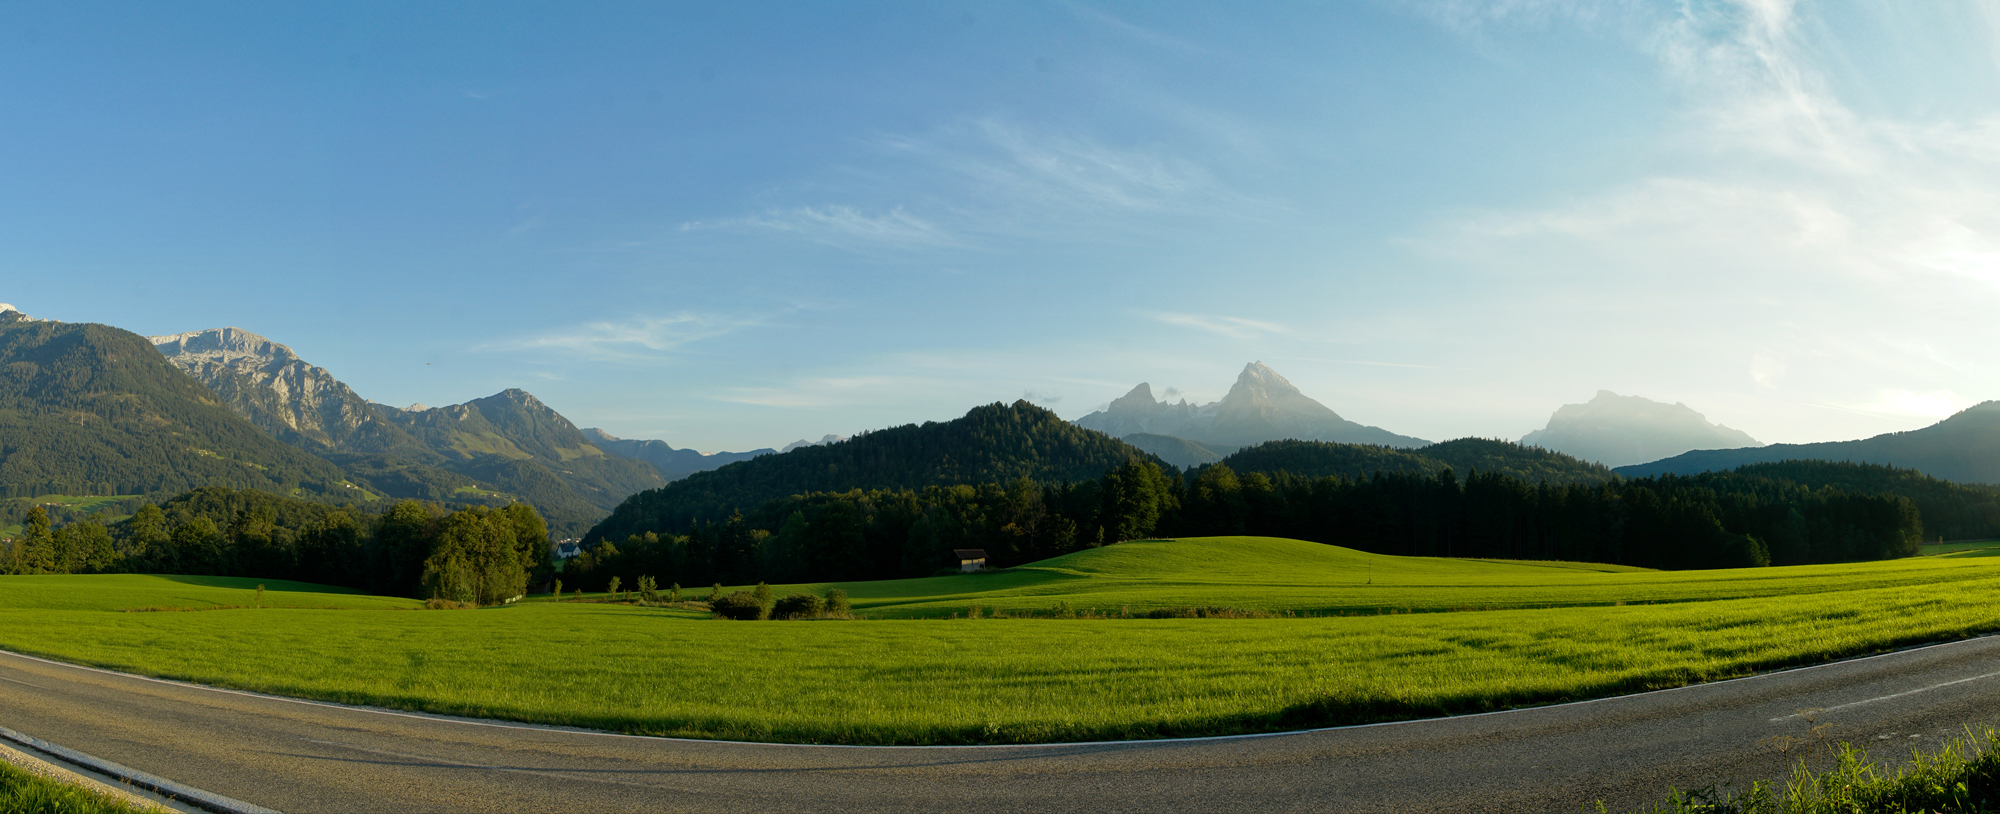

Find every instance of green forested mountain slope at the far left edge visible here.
[0,310,358,498]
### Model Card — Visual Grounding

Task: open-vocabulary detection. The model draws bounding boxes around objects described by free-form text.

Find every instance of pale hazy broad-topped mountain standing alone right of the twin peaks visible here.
[1520,390,1764,466]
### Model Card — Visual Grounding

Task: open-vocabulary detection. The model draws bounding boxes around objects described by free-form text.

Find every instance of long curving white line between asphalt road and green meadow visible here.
[0,634,2000,750]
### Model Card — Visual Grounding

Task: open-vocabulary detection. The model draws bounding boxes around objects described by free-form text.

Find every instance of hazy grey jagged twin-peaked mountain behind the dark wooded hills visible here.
[1076,362,1430,446]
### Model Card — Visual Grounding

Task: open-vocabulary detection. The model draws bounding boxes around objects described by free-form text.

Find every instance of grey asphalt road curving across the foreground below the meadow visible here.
[0,638,2000,814]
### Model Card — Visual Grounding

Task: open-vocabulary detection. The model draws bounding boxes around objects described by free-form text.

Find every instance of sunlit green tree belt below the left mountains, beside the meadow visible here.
[0,486,552,604]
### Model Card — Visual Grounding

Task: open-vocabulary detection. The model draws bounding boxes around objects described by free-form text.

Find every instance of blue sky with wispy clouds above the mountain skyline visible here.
[0,0,2000,450]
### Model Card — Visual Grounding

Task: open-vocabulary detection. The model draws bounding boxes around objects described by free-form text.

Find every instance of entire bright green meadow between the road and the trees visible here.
[0,538,2000,744]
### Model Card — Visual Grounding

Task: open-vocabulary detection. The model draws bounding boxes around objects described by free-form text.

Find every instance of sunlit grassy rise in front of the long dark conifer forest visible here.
[724,538,2000,618]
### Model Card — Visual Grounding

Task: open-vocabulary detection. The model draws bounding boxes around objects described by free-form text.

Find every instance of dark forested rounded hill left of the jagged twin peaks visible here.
[586,402,1158,540]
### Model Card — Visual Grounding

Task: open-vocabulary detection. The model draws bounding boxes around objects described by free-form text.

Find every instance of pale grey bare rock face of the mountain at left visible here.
[150,328,434,460]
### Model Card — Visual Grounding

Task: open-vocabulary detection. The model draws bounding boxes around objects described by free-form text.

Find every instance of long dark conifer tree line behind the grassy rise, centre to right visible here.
[564,458,1936,590]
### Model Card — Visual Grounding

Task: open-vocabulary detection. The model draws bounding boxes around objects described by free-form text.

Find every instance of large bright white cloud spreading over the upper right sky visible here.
[1406,0,2000,440]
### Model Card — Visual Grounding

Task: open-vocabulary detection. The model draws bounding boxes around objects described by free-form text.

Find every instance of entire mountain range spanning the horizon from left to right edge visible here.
[0,304,2000,548]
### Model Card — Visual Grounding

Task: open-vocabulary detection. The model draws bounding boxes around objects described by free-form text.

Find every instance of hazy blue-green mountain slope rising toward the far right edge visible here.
[1618,402,2000,484]
